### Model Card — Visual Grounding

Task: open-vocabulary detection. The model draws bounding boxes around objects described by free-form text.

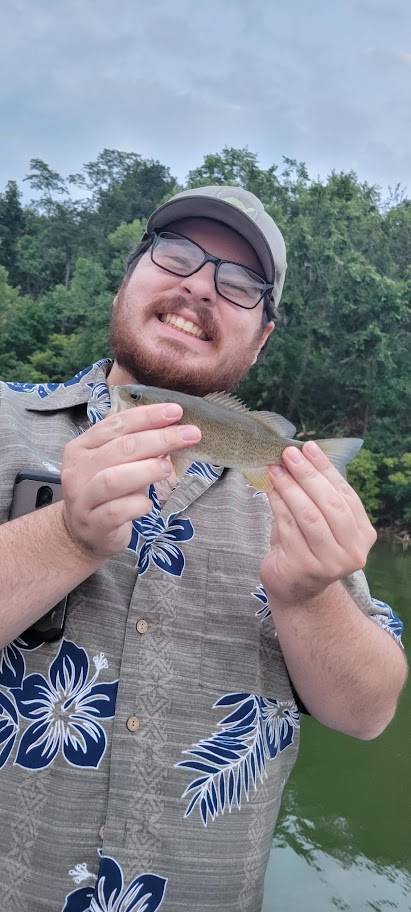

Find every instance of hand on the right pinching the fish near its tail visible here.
[261,442,377,606]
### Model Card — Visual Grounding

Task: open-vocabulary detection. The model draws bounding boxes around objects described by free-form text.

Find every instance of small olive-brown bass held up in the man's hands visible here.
[110,384,364,492]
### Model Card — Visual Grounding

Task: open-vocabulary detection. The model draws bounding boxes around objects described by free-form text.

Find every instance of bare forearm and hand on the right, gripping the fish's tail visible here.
[261,443,407,739]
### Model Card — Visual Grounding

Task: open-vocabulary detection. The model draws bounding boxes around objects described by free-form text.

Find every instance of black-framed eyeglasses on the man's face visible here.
[151,231,274,310]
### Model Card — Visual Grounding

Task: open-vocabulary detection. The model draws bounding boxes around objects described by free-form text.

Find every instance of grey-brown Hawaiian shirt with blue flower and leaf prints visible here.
[0,361,401,912]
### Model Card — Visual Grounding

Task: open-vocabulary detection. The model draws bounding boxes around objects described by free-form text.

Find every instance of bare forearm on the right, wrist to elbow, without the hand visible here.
[271,583,407,739]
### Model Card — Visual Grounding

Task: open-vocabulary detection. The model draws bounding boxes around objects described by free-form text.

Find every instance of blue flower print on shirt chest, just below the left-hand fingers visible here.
[128,485,194,576]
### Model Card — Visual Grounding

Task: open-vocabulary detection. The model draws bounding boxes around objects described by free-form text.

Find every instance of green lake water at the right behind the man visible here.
[263,544,411,912]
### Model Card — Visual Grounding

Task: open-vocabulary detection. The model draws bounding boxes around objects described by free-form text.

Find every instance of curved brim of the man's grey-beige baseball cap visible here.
[147,193,275,283]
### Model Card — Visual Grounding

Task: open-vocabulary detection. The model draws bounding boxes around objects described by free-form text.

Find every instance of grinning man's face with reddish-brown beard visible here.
[109,218,273,396]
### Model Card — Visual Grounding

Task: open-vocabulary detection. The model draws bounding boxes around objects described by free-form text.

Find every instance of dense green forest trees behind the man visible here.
[0,147,411,534]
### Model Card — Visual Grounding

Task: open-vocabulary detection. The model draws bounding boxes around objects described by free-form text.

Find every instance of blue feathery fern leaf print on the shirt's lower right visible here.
[176,693,300,826]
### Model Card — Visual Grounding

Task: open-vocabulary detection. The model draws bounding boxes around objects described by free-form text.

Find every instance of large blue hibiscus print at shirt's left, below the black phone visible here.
[11,640,118,770]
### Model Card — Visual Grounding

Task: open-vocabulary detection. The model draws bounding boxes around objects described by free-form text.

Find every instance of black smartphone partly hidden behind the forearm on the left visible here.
[9,471,68,643]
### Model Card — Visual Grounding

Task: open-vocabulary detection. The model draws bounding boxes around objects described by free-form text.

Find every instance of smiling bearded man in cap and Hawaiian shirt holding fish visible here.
[0,187,406,912]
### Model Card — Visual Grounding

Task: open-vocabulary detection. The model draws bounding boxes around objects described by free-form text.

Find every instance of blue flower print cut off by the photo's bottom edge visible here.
[62,855,167,912]
